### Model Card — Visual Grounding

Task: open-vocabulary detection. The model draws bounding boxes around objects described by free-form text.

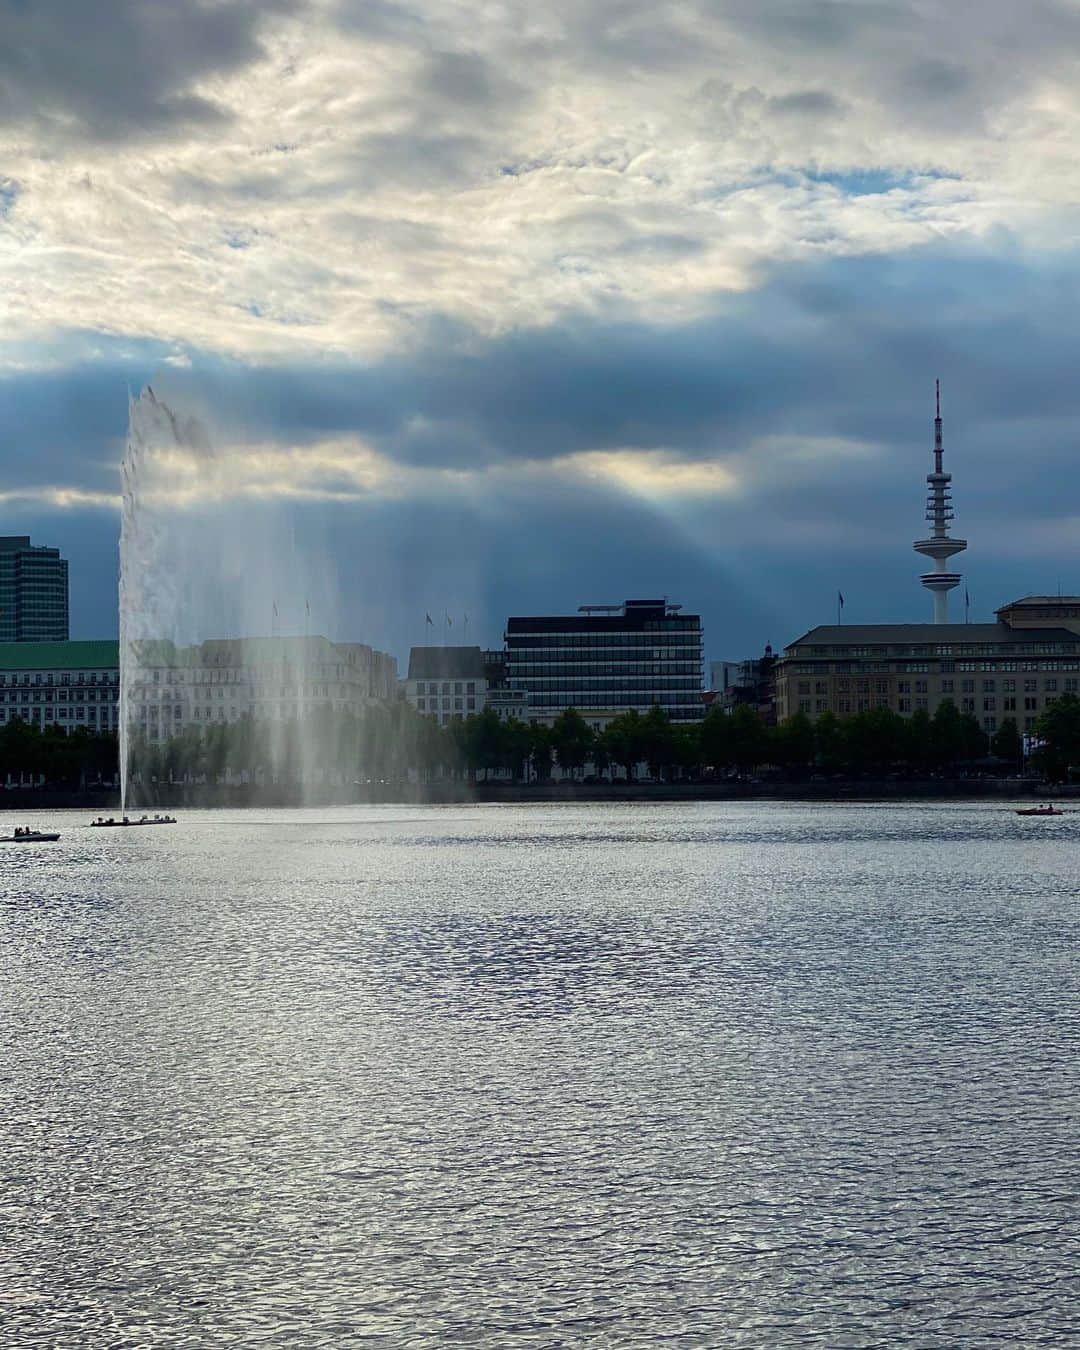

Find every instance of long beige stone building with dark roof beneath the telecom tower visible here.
[776,595,1080,733]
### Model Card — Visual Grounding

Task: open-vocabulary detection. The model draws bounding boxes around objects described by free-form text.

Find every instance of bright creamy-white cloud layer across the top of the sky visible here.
[0,0,1080,359]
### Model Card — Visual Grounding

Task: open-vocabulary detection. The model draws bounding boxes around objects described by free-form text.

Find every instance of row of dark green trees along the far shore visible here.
[0,694,1080,791]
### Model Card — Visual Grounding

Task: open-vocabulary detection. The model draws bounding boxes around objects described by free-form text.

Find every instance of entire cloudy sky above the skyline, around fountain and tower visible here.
[0,0,1080,669]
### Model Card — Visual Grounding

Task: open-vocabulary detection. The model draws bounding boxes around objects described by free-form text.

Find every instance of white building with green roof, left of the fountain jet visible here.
[0,640,120,732]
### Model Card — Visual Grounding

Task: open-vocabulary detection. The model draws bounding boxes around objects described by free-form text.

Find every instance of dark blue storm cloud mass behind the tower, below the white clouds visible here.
[0,245,1080,655]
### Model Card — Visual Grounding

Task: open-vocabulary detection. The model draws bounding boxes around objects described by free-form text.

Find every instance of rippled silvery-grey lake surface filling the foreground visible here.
[0,803,1080,1350]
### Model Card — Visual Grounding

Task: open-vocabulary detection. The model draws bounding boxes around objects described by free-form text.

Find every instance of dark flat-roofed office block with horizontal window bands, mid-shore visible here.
[506,599,703,722]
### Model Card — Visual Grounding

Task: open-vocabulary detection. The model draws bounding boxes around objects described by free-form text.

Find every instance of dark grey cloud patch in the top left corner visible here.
[0,0,284,140]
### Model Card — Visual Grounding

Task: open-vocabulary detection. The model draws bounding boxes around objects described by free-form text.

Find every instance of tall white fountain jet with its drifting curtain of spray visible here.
[120,387,353,810]
